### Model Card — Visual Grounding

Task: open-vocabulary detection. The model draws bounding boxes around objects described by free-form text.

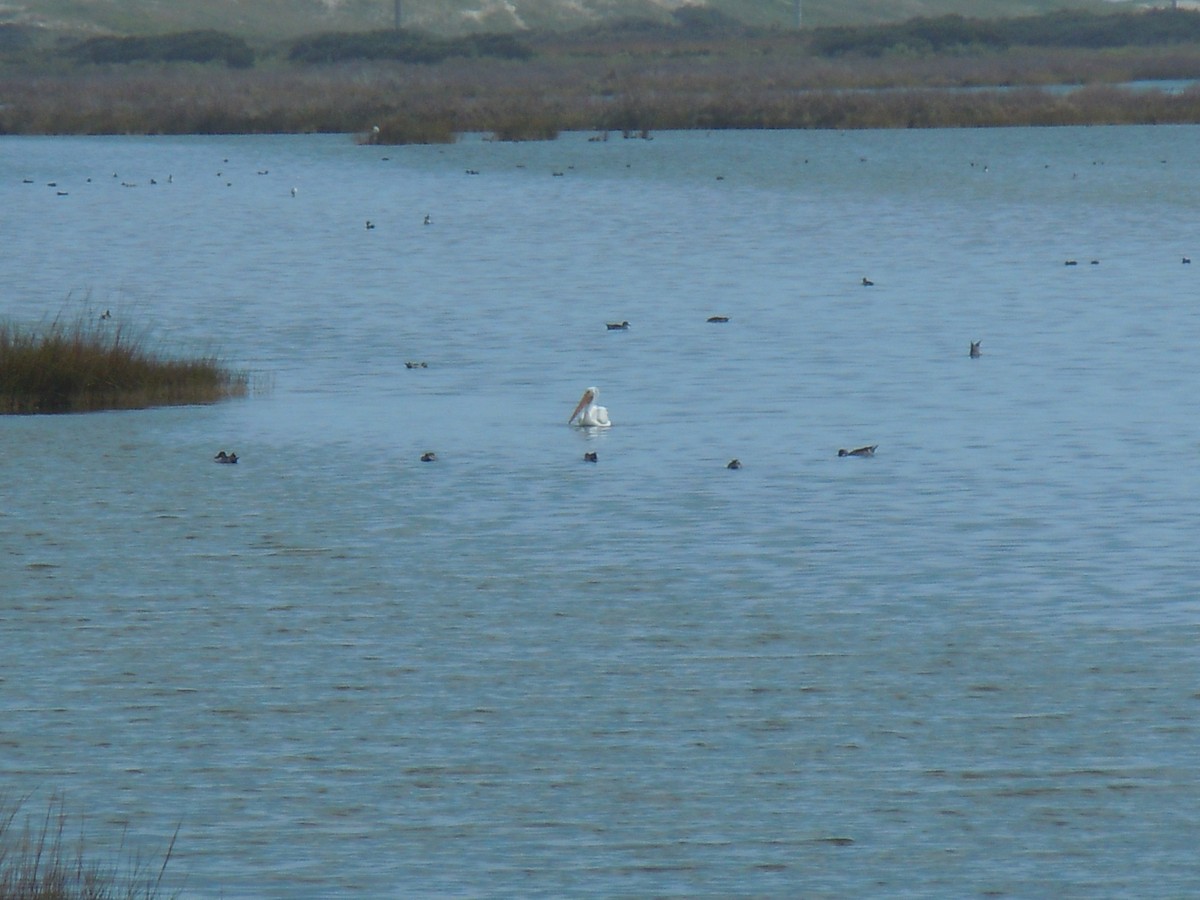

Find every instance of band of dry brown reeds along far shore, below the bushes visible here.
[0,38,1200,143]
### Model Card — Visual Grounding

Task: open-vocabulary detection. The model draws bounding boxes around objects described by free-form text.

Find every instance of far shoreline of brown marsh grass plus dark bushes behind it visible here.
[0,12,1200,137]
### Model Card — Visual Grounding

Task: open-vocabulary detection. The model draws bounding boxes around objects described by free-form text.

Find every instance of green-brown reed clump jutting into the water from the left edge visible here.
[0,318,250,414]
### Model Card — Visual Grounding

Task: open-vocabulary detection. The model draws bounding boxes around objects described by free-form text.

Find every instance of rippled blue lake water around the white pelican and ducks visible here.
[0,127,1200,898]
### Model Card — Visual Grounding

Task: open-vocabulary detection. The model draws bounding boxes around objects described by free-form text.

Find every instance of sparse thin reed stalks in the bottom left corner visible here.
[0,798,179,900]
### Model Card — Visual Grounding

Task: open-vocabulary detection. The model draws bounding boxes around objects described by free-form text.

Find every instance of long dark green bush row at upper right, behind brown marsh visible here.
[810,10,1200,56]
